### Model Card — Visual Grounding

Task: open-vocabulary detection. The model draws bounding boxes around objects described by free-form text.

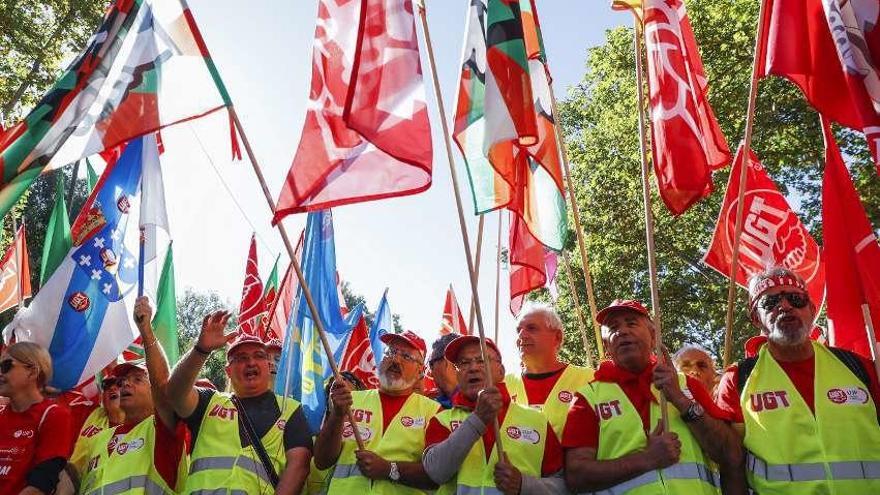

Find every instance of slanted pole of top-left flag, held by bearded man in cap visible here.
[229,106,364,450]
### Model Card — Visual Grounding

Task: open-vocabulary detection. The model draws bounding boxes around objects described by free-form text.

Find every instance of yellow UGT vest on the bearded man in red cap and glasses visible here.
[327,390,439,495]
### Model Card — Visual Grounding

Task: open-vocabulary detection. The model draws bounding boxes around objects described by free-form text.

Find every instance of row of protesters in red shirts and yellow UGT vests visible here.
[0,268,880,495]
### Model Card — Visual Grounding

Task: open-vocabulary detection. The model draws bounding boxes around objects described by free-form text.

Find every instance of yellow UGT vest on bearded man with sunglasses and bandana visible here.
[740,342,880,495]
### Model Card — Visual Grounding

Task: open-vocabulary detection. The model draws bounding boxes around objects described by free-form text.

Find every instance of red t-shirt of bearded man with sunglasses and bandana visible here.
[717,348,880,423]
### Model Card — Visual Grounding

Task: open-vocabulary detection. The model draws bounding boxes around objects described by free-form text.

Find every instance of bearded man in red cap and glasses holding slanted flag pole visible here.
[314,331,440,495]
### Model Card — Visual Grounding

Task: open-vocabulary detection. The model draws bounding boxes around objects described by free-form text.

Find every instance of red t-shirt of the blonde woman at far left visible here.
[0,399,71,495]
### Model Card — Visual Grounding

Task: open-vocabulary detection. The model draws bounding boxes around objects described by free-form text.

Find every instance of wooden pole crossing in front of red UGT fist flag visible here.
[722,0,767,369]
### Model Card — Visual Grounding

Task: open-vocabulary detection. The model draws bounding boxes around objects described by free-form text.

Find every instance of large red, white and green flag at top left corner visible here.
[0,0,230,219]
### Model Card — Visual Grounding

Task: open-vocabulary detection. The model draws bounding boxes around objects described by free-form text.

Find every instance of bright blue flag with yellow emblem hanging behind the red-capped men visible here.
[275,210,360,433]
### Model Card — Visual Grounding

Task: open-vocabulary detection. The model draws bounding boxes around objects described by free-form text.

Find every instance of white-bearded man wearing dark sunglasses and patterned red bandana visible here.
[718,268,880,494]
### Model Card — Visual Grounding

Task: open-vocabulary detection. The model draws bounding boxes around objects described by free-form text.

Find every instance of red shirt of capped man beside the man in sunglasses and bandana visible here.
[562,361,731,449]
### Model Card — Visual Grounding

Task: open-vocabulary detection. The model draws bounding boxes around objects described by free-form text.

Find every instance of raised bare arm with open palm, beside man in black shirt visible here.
[167,311,235,418]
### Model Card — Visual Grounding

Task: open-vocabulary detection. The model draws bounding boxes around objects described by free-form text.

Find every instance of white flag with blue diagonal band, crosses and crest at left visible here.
[5,135,168,390]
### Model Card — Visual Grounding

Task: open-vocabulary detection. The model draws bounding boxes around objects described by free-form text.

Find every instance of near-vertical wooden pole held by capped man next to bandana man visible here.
[633,18,669,431]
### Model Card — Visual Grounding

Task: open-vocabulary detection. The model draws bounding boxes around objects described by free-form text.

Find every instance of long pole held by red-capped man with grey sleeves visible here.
[416,0,504,459]
